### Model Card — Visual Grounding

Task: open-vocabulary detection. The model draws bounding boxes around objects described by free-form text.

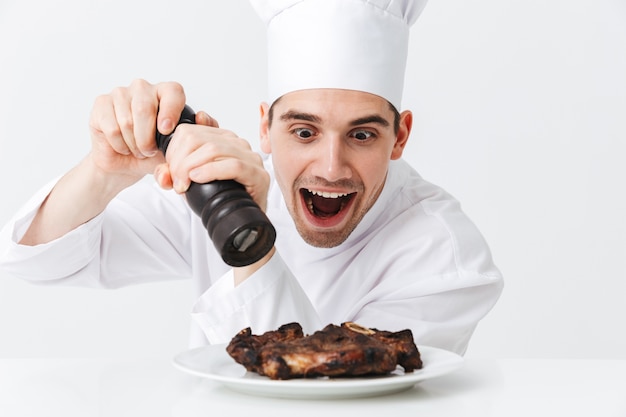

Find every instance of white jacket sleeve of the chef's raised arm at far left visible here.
[0,176,190,288]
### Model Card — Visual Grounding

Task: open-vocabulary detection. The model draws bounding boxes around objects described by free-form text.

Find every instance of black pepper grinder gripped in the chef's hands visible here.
[156,106,276,267]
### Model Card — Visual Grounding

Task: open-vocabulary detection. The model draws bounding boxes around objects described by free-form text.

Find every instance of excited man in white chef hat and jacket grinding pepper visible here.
[0,0,502,354]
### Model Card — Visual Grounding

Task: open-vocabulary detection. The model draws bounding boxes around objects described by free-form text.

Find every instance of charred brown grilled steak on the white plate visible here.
[226,323,422,379]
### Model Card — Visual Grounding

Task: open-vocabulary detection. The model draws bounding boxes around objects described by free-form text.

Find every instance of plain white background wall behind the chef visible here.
[0,0,626,359]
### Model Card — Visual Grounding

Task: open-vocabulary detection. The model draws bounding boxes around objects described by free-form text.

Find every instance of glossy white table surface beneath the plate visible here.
[0,352,626,417]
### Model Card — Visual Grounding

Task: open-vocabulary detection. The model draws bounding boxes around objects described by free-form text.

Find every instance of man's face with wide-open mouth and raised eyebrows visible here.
[261,89,412,244]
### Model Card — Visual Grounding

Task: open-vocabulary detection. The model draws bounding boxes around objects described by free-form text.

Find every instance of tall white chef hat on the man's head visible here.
[250,0,427,110]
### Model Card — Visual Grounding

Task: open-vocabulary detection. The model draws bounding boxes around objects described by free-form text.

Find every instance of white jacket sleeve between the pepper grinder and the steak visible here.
[192,252,321,344]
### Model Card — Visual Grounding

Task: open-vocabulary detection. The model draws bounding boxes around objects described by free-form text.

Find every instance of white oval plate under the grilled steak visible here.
[173,344,463,399]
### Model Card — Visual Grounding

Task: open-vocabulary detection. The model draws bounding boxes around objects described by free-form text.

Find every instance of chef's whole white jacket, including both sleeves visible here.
[0,157,502,354]
